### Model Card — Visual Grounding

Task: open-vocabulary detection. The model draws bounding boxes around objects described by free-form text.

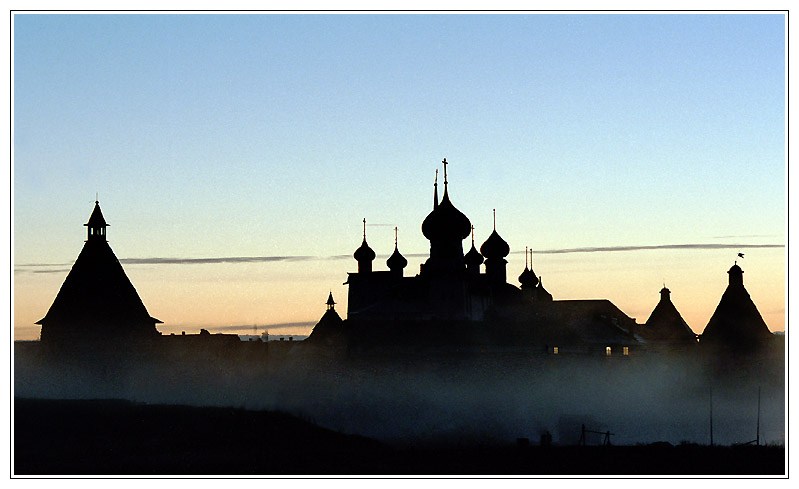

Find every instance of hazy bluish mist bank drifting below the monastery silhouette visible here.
[14,343,785,445]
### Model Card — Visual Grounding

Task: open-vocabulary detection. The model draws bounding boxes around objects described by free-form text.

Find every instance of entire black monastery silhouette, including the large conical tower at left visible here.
[36,159,774,356]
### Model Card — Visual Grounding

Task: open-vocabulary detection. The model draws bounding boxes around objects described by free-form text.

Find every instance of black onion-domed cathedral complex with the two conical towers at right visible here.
[308,159,772,356]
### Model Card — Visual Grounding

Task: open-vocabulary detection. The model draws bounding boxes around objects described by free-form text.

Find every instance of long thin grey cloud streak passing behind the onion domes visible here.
[14,243,785,273]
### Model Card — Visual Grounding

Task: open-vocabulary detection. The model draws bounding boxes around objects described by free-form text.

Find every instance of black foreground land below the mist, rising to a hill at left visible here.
[14,398,785,476]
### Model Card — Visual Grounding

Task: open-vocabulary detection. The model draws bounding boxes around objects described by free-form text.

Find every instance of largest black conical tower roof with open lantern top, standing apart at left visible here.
[36,202,161,343]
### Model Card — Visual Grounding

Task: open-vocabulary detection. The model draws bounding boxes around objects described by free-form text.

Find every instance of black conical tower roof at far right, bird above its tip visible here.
[699,263,771,351]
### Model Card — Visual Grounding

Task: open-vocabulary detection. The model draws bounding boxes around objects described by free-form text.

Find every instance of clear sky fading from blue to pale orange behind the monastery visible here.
[12,14,787,339]
